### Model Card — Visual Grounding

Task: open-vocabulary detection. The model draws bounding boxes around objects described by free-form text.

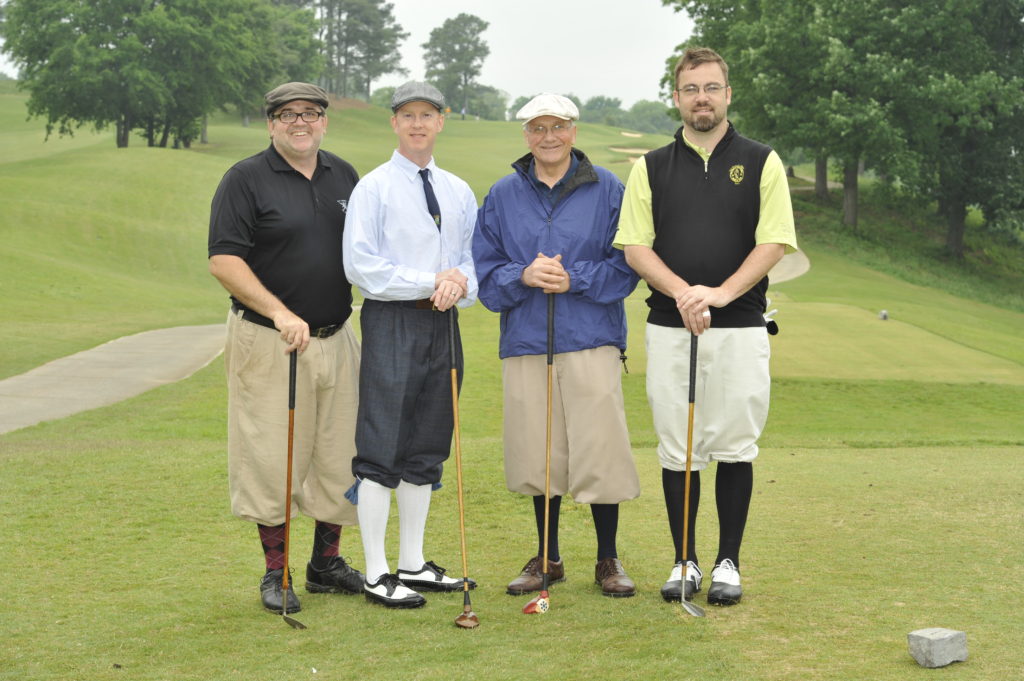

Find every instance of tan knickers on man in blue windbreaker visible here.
[502,346,640,504]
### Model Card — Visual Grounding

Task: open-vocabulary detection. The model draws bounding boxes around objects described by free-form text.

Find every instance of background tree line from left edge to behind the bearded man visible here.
[0,0,675,147]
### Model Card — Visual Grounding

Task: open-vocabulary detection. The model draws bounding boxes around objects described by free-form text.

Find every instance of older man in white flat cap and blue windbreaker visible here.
[473,94,640,597]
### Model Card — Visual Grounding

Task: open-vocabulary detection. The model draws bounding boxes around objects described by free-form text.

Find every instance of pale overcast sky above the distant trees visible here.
[0,0,692,109]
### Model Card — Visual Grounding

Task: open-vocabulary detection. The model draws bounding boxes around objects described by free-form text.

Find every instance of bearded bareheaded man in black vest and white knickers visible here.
[615,48,797,605]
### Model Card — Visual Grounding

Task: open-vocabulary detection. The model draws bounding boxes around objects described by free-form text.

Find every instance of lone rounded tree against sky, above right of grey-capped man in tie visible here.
[422,12,490,118]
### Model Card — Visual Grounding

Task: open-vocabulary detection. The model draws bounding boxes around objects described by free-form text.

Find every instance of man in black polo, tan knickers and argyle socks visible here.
[209,83,362,612]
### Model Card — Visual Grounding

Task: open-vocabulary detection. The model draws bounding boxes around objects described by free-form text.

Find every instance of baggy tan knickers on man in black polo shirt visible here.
[224,313,359,525]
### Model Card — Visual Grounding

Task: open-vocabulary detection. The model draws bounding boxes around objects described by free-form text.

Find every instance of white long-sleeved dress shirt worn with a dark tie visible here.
[342,151,477,307]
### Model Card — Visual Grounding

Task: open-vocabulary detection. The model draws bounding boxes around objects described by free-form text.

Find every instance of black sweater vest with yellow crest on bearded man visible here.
[644,123,771,328]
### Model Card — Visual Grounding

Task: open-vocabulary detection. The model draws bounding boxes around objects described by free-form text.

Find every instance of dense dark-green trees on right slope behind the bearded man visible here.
[663,0,1024,257]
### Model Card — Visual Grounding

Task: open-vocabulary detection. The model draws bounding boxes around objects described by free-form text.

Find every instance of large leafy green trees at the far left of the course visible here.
[2,0,303,146]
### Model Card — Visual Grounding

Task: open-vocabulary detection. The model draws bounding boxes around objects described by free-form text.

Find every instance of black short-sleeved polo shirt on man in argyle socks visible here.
[209,144,358,329]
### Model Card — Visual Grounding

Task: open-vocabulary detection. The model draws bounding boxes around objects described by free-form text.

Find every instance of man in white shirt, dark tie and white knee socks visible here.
[343,82,476,607]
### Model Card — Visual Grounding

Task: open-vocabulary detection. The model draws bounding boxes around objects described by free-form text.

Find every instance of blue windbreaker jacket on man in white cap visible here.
[473,150,639,358]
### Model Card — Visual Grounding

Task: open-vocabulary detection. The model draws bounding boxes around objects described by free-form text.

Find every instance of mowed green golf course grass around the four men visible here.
[0,83,1024,681]
